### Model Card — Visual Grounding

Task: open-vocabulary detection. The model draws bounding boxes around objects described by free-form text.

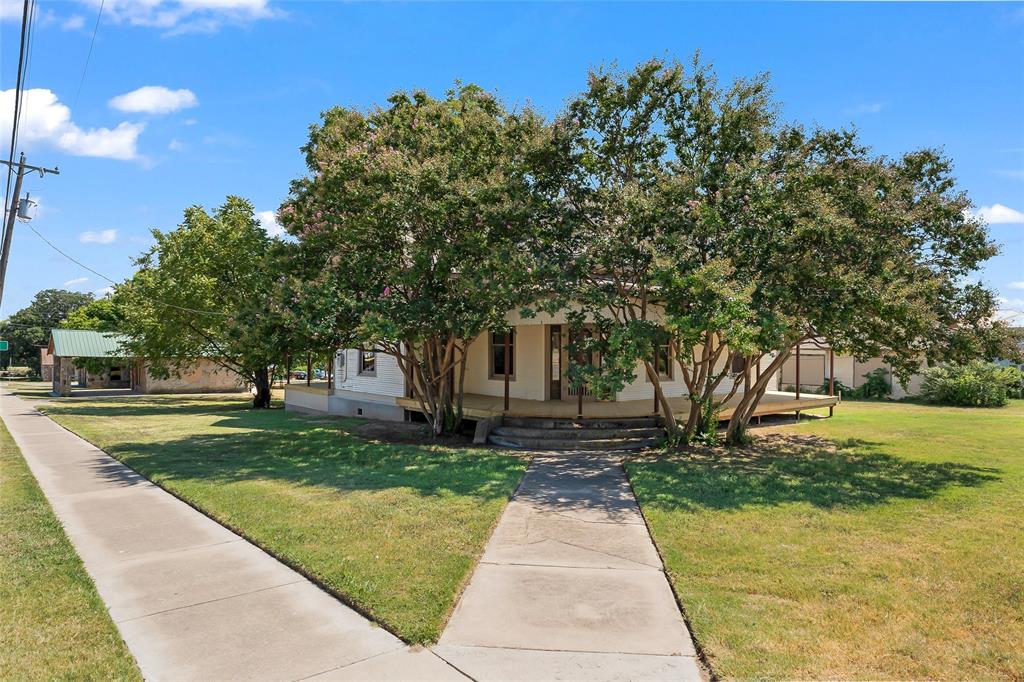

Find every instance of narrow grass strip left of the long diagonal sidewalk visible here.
[0,423,141,680]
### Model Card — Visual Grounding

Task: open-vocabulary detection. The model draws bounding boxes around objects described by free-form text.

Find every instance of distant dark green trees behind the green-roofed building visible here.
[0,289,92,374]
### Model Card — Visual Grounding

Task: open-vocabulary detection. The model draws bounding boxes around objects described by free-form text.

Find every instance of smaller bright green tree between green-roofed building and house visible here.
[116,197,295,408]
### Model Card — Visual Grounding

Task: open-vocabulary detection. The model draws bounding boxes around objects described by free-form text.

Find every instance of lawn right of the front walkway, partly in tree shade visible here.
[628,400,1024,680]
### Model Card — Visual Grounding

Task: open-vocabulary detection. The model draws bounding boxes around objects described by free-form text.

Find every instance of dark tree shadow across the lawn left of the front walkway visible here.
[46,397,525,501]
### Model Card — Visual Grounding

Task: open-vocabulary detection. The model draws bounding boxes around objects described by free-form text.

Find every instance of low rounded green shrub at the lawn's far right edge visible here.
[921,360,1022,408]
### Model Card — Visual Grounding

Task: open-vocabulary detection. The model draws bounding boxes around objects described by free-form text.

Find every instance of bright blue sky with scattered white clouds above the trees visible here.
[0,0,1024,321]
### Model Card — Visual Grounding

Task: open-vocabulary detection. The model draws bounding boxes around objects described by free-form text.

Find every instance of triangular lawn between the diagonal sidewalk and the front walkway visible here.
[37,396,526,642]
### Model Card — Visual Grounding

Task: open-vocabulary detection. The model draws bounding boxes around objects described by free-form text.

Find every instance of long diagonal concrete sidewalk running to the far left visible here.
[0,391,465,680]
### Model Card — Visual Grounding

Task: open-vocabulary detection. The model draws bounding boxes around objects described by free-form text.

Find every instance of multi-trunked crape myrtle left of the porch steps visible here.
[280,84,549,434]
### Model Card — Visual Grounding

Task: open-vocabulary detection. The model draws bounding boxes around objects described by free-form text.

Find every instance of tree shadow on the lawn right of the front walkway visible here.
[629,436,999,511]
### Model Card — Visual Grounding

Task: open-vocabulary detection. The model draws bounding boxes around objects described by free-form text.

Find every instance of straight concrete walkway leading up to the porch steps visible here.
[434,455,700,681]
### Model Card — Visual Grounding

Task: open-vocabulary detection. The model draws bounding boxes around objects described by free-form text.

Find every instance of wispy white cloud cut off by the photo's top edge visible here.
[80,0,284,35]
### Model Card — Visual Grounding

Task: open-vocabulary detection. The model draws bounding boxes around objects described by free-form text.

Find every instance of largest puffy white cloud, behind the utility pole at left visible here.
[0,88,145,161]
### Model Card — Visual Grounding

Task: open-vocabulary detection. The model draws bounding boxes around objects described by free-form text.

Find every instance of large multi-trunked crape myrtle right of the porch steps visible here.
[558,58,997,442]
